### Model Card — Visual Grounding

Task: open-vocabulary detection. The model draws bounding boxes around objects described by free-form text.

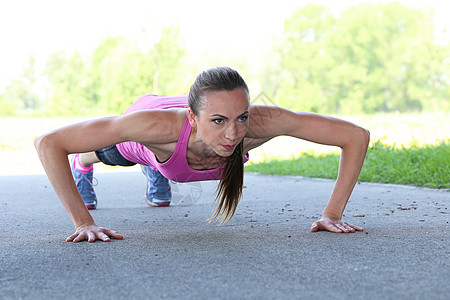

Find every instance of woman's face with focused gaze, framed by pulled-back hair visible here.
[189,88,250,157]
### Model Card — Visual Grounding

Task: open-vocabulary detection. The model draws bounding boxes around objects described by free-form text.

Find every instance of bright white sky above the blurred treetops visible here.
[0,0,450,92]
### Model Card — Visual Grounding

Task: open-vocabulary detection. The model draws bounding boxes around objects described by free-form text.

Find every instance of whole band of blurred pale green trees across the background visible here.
[0,1,450,117]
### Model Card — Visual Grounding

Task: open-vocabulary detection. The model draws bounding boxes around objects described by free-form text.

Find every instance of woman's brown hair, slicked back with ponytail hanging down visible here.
[188,67,249,223]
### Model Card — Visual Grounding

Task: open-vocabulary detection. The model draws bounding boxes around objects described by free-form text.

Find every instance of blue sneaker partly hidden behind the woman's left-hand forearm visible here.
[70,154,97,209]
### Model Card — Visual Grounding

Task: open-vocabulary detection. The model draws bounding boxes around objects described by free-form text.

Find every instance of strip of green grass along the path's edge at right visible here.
[245,139,450,188]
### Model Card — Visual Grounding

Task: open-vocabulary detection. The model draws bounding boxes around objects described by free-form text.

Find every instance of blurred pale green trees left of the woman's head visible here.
[0,28,186,116]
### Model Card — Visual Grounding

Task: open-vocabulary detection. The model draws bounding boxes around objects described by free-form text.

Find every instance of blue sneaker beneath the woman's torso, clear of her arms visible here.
[141,165,172,207]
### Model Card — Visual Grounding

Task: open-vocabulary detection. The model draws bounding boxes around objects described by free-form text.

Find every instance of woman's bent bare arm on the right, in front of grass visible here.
[249,106,370,232]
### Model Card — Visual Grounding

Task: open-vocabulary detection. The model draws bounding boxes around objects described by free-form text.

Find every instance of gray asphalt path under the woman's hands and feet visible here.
[0,172,450,299]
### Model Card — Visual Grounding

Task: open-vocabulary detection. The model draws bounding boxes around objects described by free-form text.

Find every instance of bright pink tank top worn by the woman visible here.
[117,94,248,182]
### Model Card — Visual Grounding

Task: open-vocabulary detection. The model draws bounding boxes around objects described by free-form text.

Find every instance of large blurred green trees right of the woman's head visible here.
[268,3,450,114]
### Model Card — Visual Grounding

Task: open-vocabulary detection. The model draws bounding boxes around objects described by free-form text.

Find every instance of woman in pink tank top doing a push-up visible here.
[35,67,369,242]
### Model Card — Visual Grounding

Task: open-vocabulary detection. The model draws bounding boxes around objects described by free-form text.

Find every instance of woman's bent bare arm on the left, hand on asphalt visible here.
[35,112,181,242]
